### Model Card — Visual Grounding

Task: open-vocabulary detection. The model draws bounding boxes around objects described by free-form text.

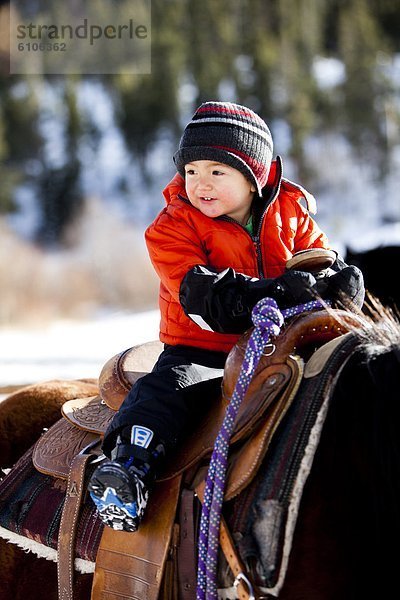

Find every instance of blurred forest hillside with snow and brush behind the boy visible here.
[0,0,400,326]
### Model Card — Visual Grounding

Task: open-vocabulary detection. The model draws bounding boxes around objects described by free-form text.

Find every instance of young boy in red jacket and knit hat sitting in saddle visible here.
[89,102,364,531]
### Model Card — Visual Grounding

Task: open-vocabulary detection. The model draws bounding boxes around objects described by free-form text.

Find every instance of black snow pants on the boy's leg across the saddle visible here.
[103,345,227,456]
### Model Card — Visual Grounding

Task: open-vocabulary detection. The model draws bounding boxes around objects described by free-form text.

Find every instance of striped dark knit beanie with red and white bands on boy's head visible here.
[174,102,273,196]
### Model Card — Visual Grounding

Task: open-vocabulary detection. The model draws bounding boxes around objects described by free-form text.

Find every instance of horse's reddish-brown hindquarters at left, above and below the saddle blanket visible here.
[0,378,98,600]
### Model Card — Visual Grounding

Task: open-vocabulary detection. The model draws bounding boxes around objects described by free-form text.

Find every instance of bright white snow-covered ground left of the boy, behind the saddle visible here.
[0,310,159,388]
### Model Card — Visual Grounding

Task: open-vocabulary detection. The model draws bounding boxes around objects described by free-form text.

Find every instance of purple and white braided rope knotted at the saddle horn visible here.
[197,298,324,600]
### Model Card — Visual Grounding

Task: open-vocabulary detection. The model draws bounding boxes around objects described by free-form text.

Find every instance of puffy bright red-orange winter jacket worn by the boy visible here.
[145,158,329,352]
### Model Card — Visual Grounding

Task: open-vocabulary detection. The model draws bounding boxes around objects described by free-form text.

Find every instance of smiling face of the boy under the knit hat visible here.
[185,160,256,225]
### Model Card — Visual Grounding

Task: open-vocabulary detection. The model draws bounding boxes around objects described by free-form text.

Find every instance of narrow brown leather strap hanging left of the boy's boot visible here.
[57,453,96,600]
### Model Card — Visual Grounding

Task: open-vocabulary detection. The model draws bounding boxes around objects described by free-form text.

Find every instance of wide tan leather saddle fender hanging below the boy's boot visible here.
[91,475,182,600]
